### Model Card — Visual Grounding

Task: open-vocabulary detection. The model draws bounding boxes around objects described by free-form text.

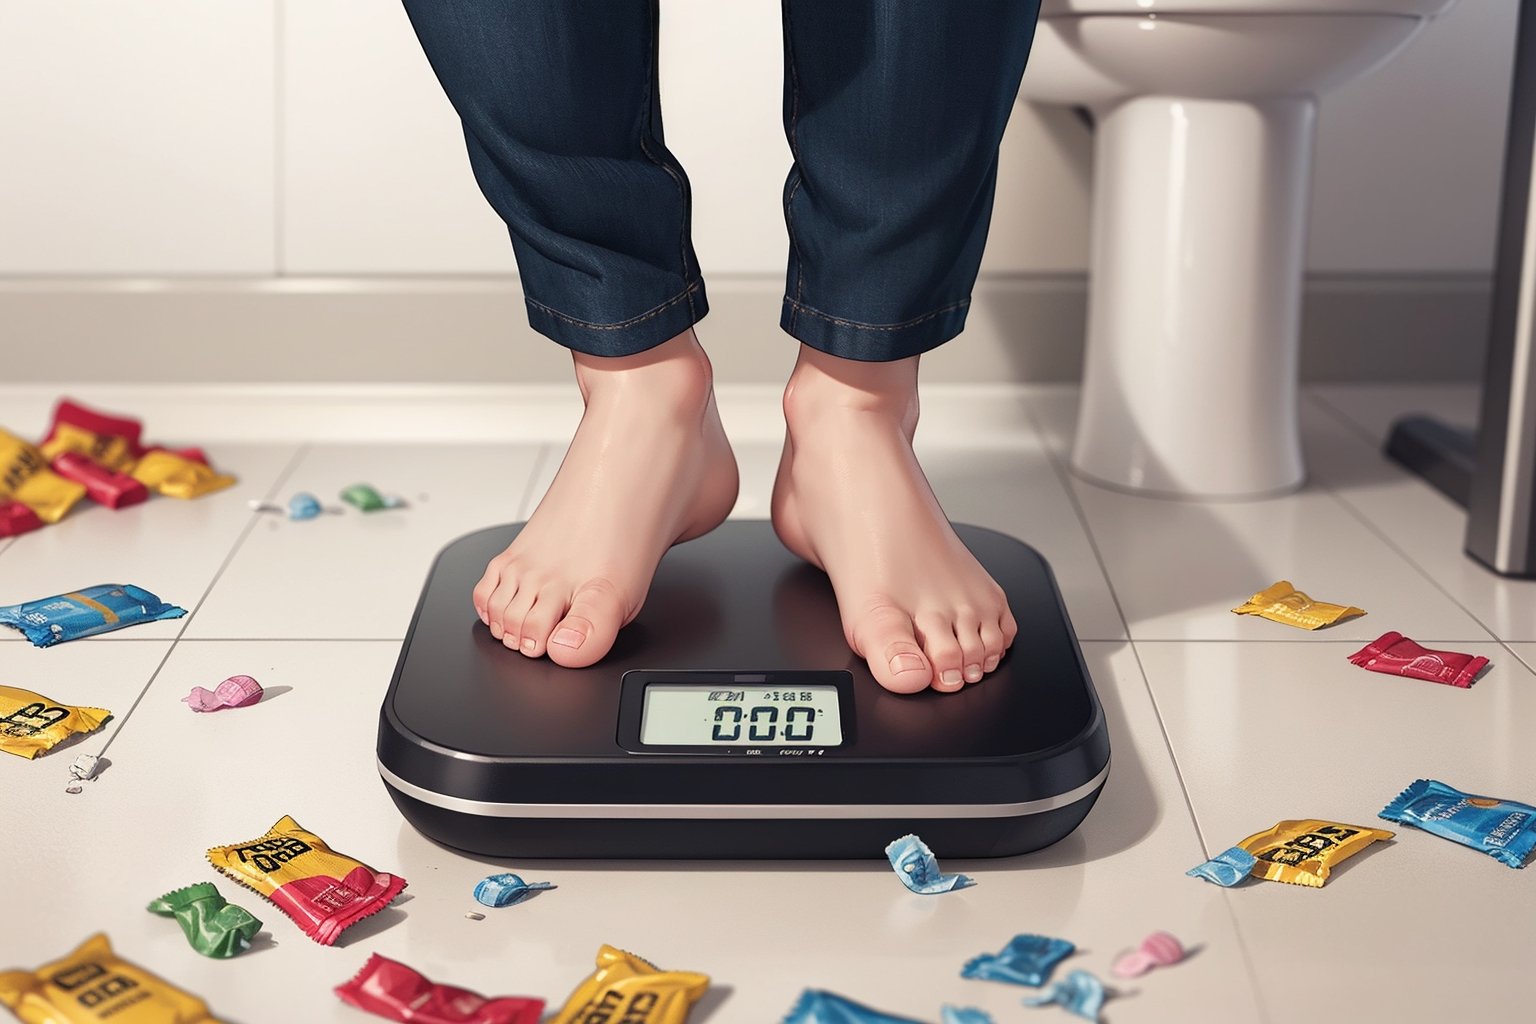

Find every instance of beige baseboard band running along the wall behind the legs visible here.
[0,273,1488,384]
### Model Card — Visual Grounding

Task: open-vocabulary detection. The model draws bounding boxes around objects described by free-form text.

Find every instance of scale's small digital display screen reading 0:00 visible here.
[641,683,843,746]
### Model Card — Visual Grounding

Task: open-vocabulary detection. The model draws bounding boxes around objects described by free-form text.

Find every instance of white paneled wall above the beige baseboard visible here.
[0,0,1516,276]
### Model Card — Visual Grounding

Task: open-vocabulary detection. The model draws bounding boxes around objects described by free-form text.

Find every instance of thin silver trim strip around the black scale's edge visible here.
[378,761,1109,820]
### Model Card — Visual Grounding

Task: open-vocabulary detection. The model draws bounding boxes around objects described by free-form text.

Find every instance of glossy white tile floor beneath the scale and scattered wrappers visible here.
[0,387,1536,1024]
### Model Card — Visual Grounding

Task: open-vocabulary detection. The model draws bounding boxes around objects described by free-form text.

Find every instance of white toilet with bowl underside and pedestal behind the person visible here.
[1021,0,1455,497]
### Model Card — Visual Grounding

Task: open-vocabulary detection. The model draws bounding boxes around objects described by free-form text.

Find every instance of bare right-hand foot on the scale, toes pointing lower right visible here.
[773,345,1018,694]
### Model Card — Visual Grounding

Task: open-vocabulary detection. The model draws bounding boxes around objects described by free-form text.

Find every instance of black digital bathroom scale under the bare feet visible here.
[378,520,1109,858]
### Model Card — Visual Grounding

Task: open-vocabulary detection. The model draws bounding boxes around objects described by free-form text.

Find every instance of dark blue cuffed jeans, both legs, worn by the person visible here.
[406,0,1040,361]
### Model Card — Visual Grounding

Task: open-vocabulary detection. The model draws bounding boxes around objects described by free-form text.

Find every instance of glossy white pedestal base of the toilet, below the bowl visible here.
[1072,97,1316,497]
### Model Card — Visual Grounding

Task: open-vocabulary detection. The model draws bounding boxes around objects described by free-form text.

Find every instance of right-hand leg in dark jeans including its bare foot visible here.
[773,0,1037,692]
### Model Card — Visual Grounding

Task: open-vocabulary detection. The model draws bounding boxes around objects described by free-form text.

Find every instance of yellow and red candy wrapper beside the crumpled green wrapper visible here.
[207,815,406,946]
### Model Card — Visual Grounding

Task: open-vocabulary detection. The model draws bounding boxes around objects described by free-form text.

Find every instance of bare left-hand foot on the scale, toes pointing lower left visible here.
[475,329,737,668]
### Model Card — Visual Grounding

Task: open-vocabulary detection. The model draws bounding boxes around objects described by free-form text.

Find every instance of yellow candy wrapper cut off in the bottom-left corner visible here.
[0,935,221,1024]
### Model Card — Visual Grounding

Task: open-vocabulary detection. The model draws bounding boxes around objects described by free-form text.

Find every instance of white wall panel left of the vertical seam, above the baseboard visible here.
[0,0,275,275]
